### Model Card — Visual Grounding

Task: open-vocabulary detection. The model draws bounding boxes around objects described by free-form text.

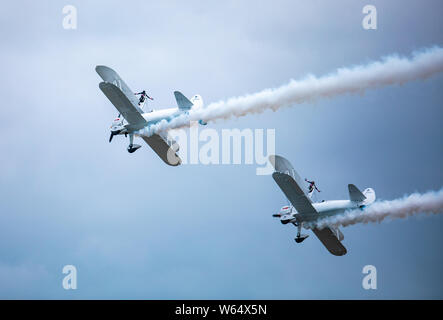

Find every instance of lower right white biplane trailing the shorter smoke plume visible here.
[269,155,375,256]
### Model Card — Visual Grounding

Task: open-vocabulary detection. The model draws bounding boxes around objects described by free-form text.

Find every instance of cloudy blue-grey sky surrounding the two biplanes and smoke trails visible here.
[0,0,443,299]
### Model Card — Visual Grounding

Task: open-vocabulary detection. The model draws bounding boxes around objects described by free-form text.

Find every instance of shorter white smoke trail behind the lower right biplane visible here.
[311,189,443,228]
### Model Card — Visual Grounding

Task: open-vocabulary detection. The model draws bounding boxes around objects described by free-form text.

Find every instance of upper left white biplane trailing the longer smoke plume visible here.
[95,66,206,166]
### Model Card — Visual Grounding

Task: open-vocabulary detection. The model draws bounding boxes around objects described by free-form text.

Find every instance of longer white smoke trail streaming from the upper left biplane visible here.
[141,47,443,135]
